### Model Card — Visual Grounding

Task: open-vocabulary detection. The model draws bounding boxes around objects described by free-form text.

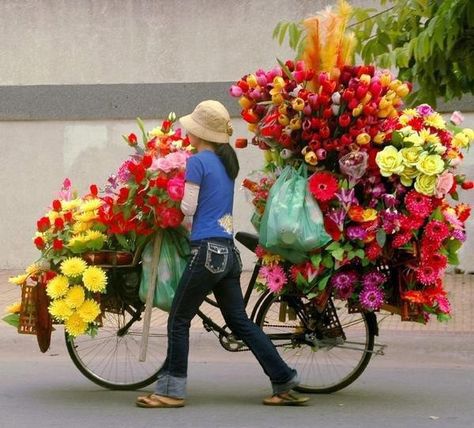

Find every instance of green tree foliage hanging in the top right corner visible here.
[351,0,474,105]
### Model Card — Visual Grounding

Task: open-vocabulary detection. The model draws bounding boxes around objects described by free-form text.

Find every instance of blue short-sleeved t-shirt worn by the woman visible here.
[186,150,234,241]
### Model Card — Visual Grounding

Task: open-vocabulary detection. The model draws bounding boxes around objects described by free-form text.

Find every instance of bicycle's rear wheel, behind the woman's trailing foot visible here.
[256,295,375,393]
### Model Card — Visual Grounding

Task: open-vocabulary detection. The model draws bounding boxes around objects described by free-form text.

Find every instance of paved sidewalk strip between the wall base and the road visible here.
[0,270,474,333]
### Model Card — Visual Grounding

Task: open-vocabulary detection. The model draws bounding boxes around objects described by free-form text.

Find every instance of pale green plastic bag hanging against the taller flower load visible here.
[260,164,331,263]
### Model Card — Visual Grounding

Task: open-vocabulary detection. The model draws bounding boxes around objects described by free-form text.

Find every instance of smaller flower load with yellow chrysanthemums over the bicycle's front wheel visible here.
[5,114,190,337]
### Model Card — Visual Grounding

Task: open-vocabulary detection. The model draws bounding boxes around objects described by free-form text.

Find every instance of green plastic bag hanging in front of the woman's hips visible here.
[139,228,190,312]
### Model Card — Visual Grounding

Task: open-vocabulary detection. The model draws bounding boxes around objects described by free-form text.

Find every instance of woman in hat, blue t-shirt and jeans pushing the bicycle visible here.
[136,100,308,408]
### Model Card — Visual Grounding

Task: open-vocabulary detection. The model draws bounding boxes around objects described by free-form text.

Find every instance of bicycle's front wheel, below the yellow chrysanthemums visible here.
[66,308,168,390]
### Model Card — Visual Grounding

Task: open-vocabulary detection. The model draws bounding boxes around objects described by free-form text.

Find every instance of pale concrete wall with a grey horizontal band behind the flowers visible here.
[0,0,474,269]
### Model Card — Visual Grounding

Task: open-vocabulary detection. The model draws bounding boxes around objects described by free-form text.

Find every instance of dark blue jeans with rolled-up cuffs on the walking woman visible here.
[155,238,298,398]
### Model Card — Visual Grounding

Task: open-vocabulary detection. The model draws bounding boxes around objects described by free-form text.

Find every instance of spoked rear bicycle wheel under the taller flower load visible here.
[256,294,376,394]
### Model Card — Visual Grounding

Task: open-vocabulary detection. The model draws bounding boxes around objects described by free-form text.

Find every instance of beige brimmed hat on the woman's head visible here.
[179,100,232,143]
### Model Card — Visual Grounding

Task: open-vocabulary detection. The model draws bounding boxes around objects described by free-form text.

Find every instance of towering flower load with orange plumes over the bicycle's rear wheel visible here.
[235,0,474,321]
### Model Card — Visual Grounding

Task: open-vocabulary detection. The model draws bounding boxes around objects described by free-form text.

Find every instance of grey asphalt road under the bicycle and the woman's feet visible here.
[0,325,474,428]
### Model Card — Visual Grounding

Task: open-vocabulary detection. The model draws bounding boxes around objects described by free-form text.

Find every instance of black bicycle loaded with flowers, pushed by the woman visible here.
[66,232,383,393]
